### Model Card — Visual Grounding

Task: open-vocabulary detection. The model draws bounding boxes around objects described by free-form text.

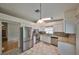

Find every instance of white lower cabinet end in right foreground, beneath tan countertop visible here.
[58,42,76,55]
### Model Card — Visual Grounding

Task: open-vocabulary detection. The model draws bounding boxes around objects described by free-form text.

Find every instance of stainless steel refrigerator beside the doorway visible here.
[20,27,33,52]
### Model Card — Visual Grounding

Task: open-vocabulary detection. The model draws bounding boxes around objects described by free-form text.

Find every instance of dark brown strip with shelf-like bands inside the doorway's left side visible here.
[2,22,8,52]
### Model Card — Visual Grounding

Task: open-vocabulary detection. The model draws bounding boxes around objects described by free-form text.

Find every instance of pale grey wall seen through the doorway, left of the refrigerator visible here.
[8,22,20,47]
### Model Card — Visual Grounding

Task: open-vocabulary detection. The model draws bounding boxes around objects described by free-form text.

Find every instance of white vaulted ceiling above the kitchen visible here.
[0,3,79,21]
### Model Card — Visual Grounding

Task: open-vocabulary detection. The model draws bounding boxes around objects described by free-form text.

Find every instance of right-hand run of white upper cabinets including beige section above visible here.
[53,9,76,34]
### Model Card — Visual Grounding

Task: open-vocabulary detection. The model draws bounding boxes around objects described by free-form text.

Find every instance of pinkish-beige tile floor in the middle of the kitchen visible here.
[22,42,59,55]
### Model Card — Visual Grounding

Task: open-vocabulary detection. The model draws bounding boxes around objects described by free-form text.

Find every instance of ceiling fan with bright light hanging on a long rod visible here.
[35,3,63,23]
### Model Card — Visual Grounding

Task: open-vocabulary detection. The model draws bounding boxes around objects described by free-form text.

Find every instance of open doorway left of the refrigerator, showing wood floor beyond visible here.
[1,21,20,54]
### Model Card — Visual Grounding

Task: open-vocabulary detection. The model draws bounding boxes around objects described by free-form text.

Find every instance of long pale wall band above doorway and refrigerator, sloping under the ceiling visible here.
[0,13,38,28]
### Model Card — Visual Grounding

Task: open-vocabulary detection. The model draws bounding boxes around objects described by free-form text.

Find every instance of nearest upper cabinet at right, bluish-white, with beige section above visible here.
[64,9,76,34]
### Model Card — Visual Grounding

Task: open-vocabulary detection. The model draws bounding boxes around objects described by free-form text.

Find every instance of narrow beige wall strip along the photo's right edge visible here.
[75,7,79,55]
